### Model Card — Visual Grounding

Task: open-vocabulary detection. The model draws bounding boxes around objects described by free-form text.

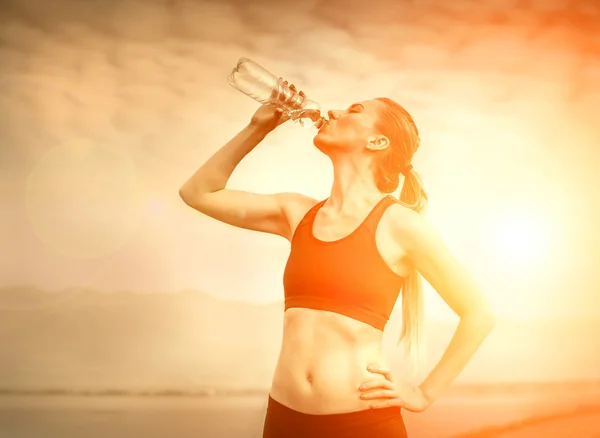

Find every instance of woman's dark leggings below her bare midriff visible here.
[262,396,407,438]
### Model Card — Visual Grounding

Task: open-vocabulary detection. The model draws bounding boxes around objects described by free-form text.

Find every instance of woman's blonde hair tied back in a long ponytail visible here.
[375,97,428,371]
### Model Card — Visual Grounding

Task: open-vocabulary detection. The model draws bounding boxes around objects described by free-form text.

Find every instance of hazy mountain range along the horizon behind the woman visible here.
[0,287,600,392]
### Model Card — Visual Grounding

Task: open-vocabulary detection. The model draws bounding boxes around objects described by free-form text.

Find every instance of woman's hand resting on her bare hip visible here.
[358,366,430,412]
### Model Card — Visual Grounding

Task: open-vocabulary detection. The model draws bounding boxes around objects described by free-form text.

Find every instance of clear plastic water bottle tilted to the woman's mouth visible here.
[228,58,327,128]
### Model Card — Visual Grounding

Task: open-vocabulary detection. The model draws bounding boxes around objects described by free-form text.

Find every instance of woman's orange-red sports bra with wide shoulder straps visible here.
[283,195,404,331]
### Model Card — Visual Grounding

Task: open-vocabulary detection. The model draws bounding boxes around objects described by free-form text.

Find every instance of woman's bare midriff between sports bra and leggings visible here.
[270,308,387,415]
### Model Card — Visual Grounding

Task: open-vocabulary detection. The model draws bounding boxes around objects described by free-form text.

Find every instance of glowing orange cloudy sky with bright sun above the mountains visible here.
[0,0,600,319]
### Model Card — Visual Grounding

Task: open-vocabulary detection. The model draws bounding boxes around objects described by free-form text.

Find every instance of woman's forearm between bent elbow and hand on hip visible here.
[420,312,495,403]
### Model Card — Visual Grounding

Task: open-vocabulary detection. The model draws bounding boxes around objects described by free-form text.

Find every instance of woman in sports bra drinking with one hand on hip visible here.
[180,86,494,438]
